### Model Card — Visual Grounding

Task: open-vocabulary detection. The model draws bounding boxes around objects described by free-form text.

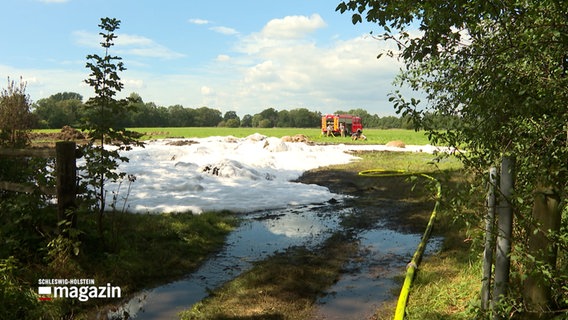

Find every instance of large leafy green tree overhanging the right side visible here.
[337,0,568,315]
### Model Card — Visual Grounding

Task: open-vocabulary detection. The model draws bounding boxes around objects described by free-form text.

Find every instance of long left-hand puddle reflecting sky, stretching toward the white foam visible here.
[107,205,347,320]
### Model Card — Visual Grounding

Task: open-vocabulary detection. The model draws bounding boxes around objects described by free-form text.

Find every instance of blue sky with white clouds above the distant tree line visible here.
[0,0,408,116]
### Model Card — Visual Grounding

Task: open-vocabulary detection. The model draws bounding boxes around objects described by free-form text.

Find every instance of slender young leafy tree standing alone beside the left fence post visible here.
[83,18,142,238]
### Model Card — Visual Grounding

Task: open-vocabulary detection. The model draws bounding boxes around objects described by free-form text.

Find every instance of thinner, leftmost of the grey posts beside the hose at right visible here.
[481,167,497,310]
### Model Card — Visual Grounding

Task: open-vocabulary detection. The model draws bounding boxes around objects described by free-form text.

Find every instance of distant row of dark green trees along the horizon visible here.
[32,92,459,129]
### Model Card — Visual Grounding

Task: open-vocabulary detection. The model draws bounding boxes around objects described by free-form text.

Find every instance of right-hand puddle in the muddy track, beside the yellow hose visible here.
[316,229,442,319]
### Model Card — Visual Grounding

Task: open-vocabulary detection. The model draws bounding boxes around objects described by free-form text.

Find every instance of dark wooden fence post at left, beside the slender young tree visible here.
[55,141,77,228]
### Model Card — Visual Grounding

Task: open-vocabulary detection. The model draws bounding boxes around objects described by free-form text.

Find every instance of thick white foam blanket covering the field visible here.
[107,134,446,213]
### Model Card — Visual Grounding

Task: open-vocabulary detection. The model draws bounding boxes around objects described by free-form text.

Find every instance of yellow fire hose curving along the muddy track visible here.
[359,169,442,320]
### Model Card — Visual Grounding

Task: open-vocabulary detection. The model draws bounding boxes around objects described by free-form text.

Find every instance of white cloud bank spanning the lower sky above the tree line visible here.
[0,15,401,116]
